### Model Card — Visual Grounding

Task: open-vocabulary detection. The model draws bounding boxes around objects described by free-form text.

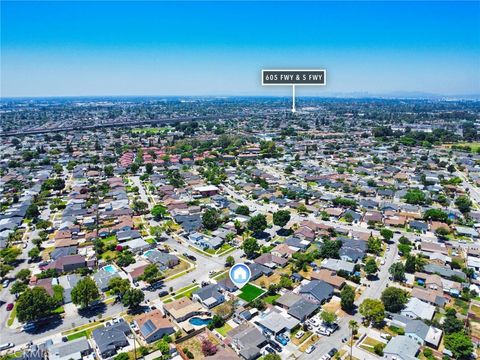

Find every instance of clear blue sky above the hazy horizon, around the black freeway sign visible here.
[1,1,480,97]
